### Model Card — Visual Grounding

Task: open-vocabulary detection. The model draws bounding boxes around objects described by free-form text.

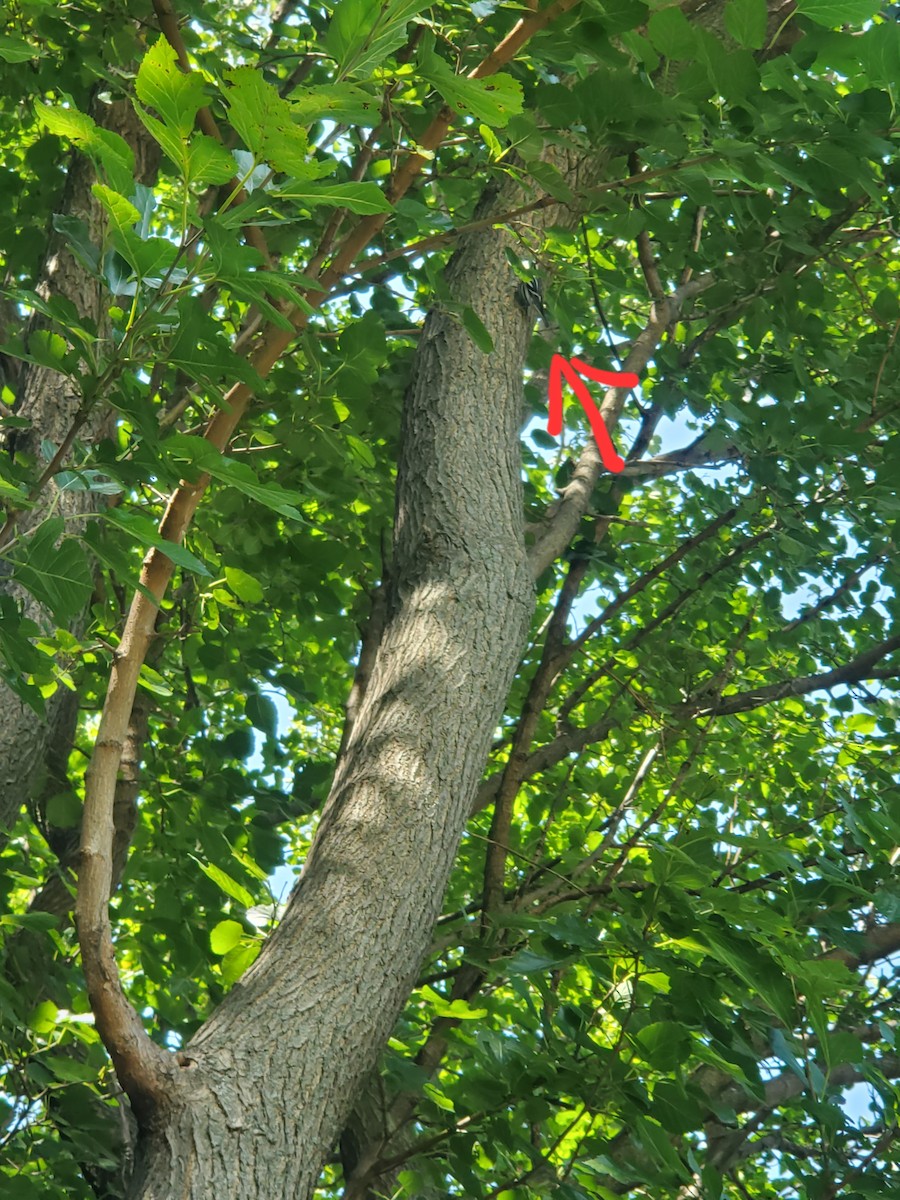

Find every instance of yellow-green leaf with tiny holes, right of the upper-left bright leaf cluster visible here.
[226,67,320,179]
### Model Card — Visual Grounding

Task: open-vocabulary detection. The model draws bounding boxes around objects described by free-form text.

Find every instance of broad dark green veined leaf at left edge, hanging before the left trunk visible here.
[13,517,94,625]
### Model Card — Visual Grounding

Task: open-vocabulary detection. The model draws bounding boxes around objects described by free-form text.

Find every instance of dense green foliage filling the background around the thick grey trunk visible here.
[0,0,900,1200]
